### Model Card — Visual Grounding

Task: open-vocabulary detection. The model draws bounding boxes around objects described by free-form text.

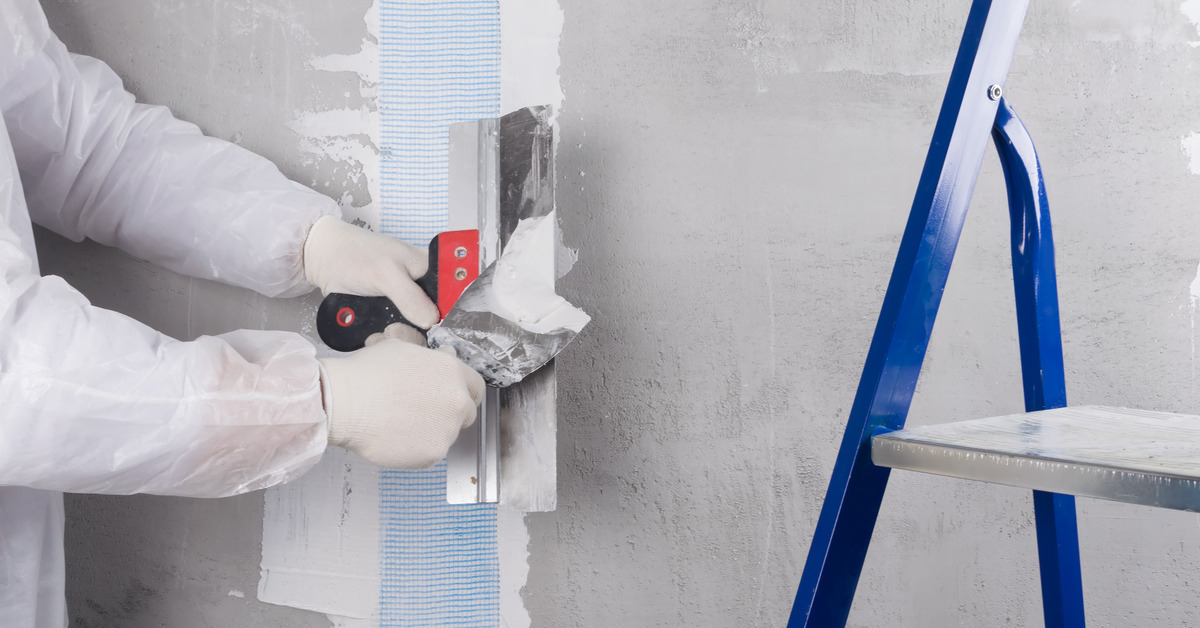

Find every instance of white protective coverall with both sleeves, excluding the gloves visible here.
[0,0,338,628]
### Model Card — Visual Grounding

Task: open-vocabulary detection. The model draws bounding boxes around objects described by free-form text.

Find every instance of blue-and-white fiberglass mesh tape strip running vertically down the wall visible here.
[379,0,500,628]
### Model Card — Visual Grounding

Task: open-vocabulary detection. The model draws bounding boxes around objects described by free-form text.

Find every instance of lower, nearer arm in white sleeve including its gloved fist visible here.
[0,217,484,497]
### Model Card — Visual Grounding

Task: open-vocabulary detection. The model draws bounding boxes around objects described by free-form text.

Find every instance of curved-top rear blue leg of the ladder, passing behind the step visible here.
[992,98,1085,628]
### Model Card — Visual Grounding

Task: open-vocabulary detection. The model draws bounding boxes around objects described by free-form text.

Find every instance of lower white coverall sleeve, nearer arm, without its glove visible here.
[0,206,328,497]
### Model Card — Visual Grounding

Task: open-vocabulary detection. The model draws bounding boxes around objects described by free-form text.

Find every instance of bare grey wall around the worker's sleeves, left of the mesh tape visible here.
[38,0,371,627]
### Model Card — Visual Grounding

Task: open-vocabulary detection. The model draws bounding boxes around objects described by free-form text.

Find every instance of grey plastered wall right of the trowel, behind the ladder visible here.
[535,0,1200,628]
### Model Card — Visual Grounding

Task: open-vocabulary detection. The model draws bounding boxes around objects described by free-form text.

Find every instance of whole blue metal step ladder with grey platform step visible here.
[788,0,1200,628]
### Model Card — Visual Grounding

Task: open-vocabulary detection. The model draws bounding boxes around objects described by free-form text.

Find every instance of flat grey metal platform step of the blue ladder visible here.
[871,406,1200,513]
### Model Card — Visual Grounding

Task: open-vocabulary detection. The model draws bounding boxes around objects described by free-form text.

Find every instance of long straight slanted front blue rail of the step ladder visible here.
[788,0,1028,628]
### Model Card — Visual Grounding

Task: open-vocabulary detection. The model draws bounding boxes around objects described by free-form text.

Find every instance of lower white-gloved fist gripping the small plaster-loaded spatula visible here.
[320,337,484,468]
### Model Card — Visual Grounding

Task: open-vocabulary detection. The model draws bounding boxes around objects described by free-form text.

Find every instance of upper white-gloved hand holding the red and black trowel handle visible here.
[304,216,439,329]
